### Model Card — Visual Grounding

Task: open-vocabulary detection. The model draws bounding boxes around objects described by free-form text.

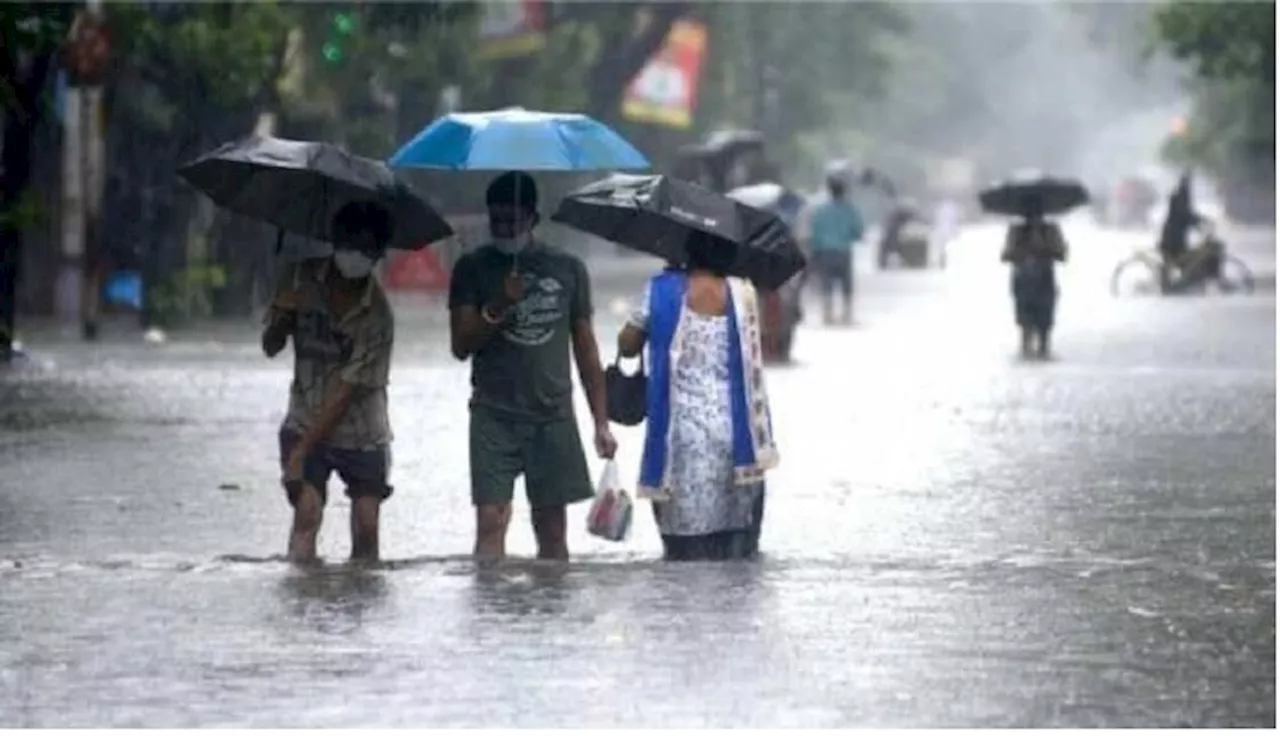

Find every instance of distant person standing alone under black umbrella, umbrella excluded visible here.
[1000,209,1066,358]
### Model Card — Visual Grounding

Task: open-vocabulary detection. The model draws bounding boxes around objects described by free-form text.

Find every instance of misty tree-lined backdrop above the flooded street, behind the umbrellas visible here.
[0,0,1275,332]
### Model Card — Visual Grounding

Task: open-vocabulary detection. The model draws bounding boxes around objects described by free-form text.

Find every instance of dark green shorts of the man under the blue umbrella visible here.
[471,408,595,508]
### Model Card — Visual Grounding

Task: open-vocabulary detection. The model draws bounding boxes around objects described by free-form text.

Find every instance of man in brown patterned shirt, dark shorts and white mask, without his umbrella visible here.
[262,198,394,562]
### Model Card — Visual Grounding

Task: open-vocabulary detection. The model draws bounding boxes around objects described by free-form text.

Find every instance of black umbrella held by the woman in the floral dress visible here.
[552,174,805,291]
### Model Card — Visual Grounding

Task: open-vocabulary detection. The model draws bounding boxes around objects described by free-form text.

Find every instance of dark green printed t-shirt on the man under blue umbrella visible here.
[449,243,591,421]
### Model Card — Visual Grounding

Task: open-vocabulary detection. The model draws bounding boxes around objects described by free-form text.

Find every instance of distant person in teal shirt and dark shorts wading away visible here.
[808,175,865,325]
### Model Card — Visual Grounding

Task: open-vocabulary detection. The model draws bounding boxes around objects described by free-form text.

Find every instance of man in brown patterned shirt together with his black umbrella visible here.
[179,136,453,562]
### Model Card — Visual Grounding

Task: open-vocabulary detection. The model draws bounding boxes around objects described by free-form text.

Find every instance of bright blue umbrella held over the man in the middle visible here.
[388,108,649,172]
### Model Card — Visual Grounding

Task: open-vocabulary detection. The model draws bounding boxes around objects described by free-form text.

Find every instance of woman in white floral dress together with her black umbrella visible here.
[552,175,805,559]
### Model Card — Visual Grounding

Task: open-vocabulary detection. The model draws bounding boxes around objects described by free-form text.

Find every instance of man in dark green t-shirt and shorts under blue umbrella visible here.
[449,172,617,559]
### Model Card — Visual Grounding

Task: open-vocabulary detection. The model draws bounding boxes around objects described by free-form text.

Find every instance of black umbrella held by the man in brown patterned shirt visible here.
[178,136,453,250]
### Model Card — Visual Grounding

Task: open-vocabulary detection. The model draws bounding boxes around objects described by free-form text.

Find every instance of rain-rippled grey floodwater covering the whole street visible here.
[0,224,1276,727]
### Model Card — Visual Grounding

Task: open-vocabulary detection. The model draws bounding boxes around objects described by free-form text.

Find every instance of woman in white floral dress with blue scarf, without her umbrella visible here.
[618,236,777,559]
